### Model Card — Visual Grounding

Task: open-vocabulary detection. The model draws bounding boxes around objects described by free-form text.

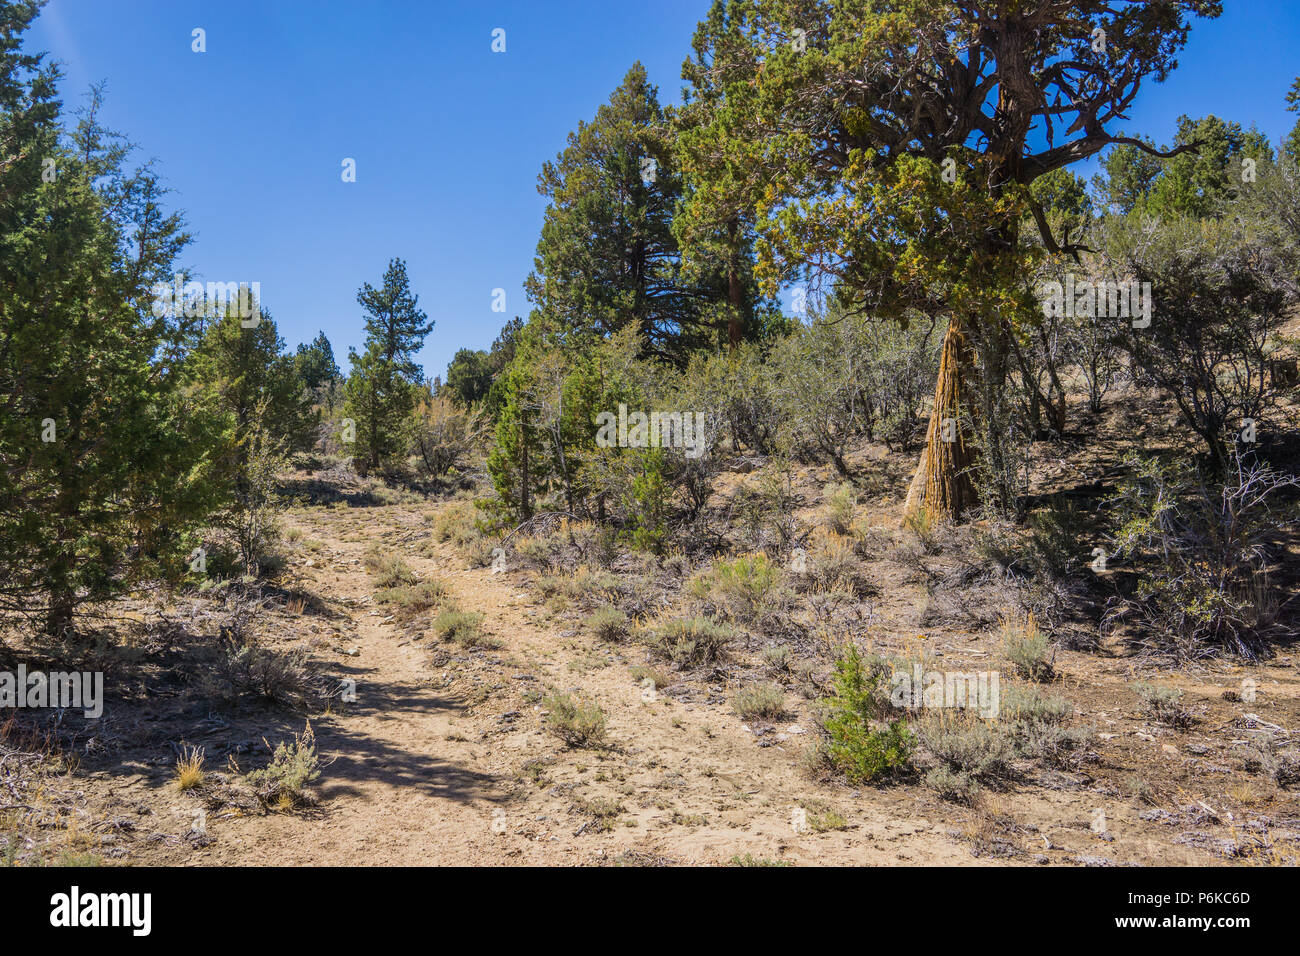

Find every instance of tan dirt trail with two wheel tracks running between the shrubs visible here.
[195,507,972,865]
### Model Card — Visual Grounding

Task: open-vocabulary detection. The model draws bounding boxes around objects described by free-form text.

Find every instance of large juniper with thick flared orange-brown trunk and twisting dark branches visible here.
[684,0,1221,516]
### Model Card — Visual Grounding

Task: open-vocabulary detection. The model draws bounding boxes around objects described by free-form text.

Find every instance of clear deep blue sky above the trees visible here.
[29,0,1300,375]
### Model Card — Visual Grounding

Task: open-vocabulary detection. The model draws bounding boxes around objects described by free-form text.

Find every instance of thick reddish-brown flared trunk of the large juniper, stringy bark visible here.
[904,317,978,520]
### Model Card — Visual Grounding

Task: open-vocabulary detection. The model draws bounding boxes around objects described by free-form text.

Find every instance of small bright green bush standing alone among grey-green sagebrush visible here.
[823,645,913,783]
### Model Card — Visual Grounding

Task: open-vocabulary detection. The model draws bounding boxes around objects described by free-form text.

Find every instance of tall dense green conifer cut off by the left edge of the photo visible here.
[0,54,220,635]
